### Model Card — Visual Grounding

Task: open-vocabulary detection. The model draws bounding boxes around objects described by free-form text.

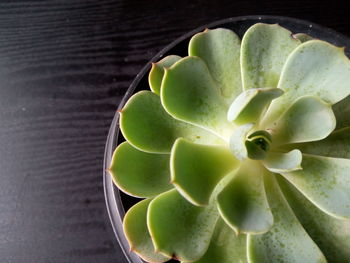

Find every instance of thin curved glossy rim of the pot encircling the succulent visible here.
[103,15,350,263]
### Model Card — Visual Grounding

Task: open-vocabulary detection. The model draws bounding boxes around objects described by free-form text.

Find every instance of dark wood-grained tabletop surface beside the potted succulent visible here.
[0,0,350,263]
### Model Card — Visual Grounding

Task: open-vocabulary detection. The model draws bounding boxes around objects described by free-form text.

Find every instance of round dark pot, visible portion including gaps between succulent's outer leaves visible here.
[103,16,350,263]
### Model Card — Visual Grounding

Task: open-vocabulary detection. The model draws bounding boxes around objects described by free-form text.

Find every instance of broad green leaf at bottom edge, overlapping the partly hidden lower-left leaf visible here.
[147,189,218,261]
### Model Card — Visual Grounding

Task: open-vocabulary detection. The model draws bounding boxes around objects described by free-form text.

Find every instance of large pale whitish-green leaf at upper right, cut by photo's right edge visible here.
[265,40,350,126]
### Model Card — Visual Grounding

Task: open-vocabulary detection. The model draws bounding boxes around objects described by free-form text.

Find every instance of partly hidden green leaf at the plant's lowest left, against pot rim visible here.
[123,199,169,263]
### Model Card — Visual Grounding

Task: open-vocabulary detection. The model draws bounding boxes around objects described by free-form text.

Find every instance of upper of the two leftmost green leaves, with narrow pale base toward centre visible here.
[120,91,221,153]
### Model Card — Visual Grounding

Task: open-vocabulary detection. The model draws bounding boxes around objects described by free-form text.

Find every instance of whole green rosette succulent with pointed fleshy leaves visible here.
[110,23,350,263]
